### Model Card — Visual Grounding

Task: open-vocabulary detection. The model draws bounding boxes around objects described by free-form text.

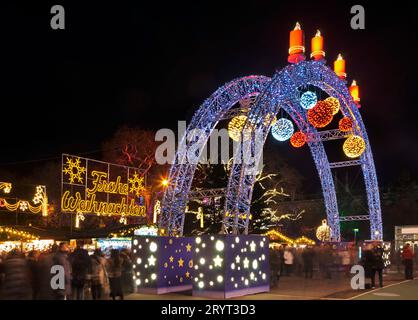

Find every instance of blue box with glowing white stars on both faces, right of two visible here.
[193,235,270,298]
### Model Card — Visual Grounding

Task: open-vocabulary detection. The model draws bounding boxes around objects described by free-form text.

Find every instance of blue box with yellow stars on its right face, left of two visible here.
[132,236,194,294]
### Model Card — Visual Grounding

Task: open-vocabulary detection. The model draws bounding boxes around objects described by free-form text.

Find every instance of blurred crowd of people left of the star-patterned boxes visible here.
[0,242,133,300]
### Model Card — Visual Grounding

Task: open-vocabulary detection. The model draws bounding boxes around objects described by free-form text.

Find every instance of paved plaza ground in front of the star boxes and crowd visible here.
[126,271,418,300]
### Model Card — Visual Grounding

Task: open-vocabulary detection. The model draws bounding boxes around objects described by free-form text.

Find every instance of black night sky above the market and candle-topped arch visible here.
[0,0,418,188]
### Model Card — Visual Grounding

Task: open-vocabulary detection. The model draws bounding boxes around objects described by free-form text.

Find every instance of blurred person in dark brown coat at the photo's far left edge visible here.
[0,249,32,300]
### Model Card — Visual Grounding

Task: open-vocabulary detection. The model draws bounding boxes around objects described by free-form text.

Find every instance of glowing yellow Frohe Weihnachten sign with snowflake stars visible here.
[61,154,146,217]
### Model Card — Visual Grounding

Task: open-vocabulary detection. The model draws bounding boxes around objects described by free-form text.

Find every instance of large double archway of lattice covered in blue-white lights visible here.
[159,61,382,241]
